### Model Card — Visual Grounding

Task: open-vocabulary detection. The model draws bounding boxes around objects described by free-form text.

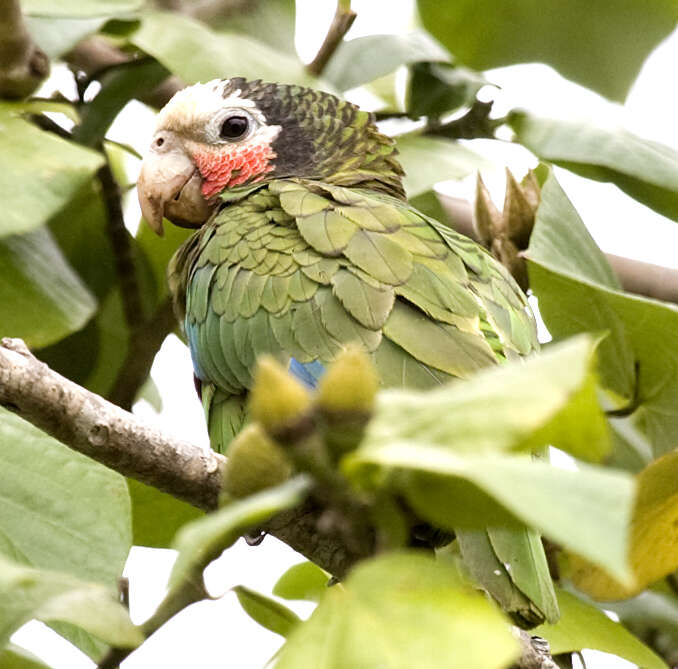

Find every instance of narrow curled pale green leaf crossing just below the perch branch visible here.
[170,476,310,589]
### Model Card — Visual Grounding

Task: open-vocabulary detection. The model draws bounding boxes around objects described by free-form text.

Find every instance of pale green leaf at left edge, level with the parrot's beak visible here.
[0,102,103,237]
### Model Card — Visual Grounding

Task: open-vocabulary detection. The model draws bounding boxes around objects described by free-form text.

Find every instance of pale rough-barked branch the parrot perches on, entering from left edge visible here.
[0,339,368,577]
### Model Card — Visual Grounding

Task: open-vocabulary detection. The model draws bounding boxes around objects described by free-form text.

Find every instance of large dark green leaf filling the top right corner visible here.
[417,0,678,101]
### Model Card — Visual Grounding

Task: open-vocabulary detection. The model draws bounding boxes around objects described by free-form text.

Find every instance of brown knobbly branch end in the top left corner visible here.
[0,0,49,98]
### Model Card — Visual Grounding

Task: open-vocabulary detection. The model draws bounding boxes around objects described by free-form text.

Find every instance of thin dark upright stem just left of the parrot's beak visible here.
[97,154,144,332]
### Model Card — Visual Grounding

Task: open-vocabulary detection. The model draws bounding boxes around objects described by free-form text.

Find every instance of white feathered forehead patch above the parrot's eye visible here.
[156,79,266,131]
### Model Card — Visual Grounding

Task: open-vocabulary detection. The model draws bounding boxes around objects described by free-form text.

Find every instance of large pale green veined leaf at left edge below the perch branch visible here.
[0,409,132,587]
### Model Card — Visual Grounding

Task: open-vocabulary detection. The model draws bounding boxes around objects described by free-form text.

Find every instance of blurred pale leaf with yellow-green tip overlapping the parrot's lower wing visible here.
[363,337,609,460]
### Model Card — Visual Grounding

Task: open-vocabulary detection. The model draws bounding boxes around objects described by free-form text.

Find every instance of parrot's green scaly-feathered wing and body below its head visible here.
[170,179,537,454]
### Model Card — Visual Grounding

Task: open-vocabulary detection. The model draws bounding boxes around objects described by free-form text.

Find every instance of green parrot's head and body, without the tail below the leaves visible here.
[138,78,556,628]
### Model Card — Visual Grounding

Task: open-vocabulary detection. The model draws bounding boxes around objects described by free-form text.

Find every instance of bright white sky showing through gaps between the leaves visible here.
[13,0,678,669]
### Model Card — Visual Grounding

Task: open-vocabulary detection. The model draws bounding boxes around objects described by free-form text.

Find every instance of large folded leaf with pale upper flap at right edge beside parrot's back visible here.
[527,175,678,455]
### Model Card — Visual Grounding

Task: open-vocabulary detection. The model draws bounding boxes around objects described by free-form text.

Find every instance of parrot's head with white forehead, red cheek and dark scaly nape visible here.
[138,77,404,235]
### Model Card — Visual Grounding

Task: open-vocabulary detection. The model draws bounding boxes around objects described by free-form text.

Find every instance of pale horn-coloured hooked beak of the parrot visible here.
[137,130,213,237]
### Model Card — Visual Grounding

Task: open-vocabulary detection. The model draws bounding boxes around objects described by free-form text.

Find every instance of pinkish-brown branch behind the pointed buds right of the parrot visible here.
[437,193,678,303]
